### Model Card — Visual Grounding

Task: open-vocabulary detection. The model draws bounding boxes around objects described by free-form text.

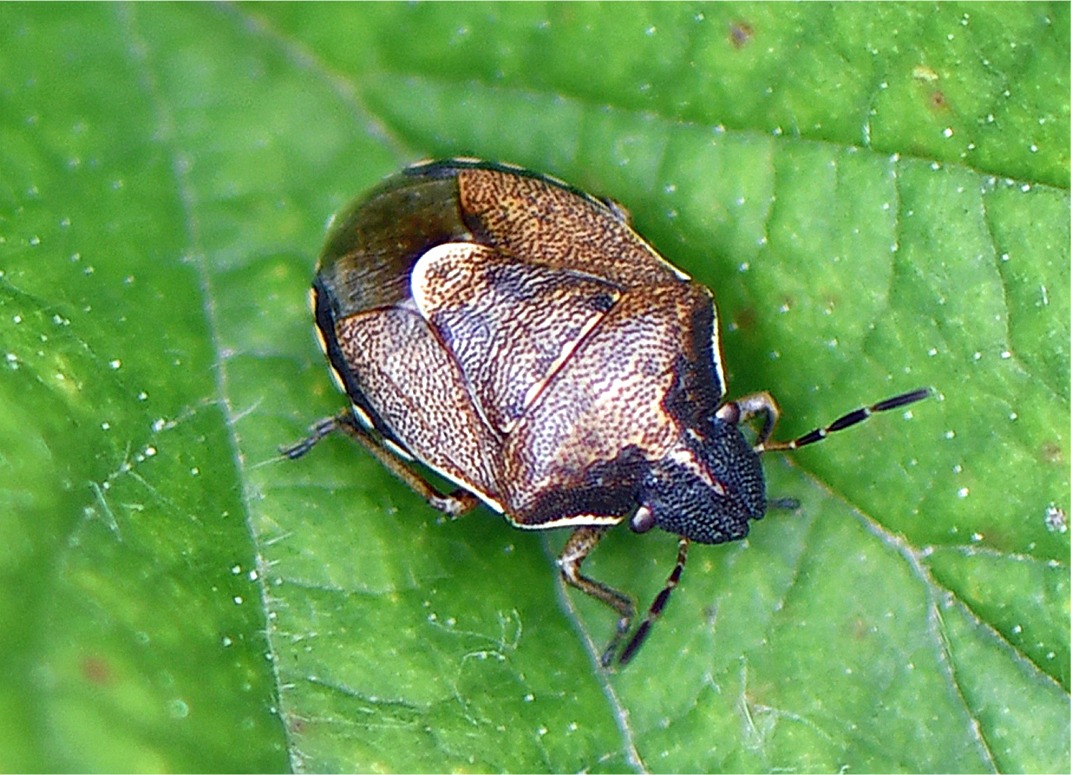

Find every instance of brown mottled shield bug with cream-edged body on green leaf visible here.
[285,159,929,666]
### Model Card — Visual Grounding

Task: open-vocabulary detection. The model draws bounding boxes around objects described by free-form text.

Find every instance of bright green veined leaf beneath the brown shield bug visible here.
[0,3,1071,772]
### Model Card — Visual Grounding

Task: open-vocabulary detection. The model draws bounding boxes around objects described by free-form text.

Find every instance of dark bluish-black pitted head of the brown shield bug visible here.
[630,416,766,544]
